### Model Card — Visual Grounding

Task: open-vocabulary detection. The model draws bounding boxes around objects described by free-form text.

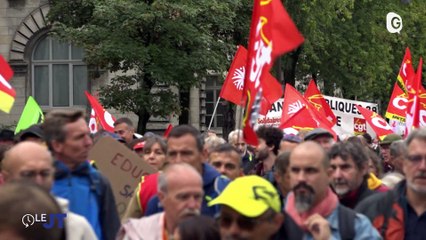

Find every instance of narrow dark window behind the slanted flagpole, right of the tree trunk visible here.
[206,75,225,128]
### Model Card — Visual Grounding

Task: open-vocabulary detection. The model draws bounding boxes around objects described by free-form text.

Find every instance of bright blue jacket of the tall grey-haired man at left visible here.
[52,161,120,240]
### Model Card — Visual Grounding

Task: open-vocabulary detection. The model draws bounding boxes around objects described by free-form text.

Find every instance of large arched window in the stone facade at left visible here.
[31,36,88,107]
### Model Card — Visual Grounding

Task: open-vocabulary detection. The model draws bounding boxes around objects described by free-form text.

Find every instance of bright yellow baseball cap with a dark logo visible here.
[208,175,281,218]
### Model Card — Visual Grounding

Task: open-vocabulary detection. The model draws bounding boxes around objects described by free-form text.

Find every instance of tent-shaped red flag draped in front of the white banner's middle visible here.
[280,100,337,140]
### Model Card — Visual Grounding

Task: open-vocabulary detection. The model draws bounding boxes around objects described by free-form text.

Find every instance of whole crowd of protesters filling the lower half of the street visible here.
[0,110,426,240]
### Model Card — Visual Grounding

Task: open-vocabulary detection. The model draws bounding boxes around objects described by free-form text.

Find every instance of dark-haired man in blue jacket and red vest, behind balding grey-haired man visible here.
[138,125,229,217]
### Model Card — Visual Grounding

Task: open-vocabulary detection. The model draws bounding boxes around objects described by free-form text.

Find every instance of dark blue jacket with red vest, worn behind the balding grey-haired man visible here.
[144,163,230,217]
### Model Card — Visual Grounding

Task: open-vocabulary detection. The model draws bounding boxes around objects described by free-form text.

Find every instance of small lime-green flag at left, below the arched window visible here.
[15,96,44,135]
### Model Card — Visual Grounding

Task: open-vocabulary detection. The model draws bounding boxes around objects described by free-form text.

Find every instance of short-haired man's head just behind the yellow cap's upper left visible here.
[209,143,243,180]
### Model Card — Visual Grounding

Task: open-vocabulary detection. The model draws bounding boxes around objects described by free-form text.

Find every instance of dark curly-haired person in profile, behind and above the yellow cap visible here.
[254,126,283,182]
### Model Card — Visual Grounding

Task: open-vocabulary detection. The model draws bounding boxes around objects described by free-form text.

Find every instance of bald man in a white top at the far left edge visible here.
[2,141,97,240]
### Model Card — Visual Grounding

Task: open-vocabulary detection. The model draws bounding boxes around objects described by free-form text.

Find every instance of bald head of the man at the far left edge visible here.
[2,142,54,191]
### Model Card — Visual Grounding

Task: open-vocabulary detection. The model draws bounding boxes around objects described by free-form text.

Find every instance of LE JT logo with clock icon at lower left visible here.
[21,213,67,229]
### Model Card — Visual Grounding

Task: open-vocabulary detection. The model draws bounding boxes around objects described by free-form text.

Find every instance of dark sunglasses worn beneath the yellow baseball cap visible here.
[217,212,275,231]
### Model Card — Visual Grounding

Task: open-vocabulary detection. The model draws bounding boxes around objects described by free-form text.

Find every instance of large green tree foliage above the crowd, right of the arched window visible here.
[49,0,251,132]
